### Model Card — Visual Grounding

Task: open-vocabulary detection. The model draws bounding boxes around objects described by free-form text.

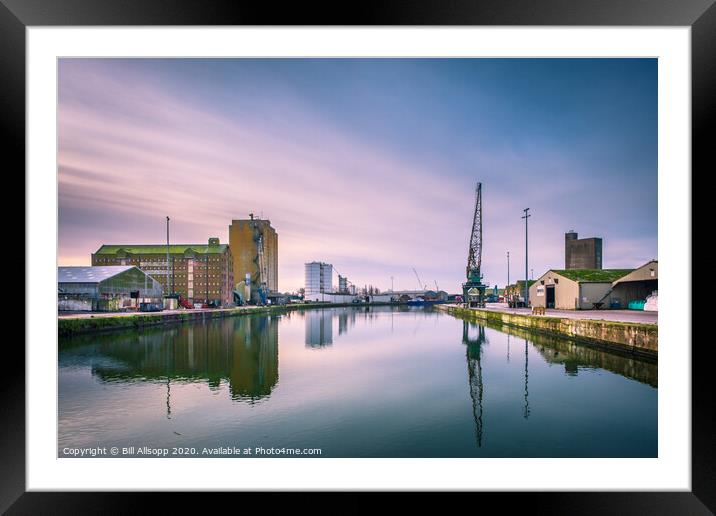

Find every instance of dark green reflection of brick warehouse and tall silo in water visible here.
[92,316,278,404]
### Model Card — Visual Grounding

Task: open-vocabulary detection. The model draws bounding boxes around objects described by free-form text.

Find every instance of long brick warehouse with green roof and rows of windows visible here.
[92,238,234,306]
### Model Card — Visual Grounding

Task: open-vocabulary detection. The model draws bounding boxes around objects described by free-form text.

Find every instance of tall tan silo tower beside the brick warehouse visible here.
[229,213,278,301]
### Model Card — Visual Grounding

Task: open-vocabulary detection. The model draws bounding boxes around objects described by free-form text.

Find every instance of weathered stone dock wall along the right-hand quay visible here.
[437,305,659,357]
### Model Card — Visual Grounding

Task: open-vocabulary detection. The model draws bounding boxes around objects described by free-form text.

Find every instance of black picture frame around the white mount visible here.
[5,0,716,514]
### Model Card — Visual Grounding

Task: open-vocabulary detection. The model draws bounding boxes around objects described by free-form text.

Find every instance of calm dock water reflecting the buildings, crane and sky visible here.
[58,307,658,457]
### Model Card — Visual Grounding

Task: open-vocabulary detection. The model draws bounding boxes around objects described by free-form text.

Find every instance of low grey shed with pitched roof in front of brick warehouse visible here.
[57,265,162,312]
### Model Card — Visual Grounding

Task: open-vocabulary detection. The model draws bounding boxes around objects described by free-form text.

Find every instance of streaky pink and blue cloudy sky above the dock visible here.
[58,59,658,293]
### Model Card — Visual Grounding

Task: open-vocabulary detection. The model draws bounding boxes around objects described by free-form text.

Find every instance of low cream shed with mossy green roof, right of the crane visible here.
[529,269,634,310]
